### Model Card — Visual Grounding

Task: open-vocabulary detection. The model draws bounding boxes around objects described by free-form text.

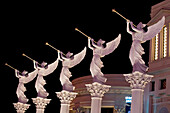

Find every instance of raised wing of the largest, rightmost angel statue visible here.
[143,16,165,41]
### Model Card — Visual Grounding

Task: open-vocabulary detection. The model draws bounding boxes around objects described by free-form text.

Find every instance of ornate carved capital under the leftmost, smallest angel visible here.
[13,102,30,113]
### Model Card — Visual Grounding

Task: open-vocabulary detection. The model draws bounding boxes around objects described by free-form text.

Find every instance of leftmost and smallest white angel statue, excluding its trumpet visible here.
[15,69,38,104]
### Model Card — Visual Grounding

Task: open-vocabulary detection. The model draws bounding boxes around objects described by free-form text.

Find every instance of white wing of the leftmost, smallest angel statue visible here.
[19,69,38,84]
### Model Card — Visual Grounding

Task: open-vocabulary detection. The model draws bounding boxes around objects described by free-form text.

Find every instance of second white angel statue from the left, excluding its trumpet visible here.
[33,58,58,98]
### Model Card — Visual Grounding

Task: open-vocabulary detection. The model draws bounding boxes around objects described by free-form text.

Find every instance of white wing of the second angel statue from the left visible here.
[43,58,59,76]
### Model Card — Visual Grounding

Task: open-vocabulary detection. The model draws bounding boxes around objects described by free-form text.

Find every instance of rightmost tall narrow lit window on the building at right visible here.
[163,26,167,57]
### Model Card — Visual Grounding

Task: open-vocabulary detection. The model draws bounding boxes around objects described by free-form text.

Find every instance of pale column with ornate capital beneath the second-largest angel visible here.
[86,82,111,113]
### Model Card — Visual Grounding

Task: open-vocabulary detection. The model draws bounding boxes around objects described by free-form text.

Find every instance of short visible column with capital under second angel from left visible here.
[32,97,51,113]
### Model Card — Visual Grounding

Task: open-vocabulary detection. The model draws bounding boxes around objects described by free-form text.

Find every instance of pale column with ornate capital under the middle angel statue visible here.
[56,90,78,113]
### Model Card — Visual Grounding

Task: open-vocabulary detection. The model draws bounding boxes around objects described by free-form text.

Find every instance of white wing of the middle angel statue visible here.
[68,47,87,68]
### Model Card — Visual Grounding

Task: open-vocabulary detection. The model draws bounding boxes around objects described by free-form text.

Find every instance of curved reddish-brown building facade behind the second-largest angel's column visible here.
[70,74,131,113]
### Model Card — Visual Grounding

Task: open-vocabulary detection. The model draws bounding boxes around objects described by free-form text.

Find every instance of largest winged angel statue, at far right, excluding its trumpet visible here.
[127,17,165,73]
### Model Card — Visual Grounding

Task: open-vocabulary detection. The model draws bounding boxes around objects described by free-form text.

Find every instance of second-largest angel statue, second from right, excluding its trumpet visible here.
[88,34,121,84]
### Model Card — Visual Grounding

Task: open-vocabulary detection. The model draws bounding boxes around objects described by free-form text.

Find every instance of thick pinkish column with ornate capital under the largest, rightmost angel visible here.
[124,71,153,113]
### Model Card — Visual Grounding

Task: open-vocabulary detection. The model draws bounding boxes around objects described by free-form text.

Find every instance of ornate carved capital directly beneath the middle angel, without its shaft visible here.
[56,90,78,104]
